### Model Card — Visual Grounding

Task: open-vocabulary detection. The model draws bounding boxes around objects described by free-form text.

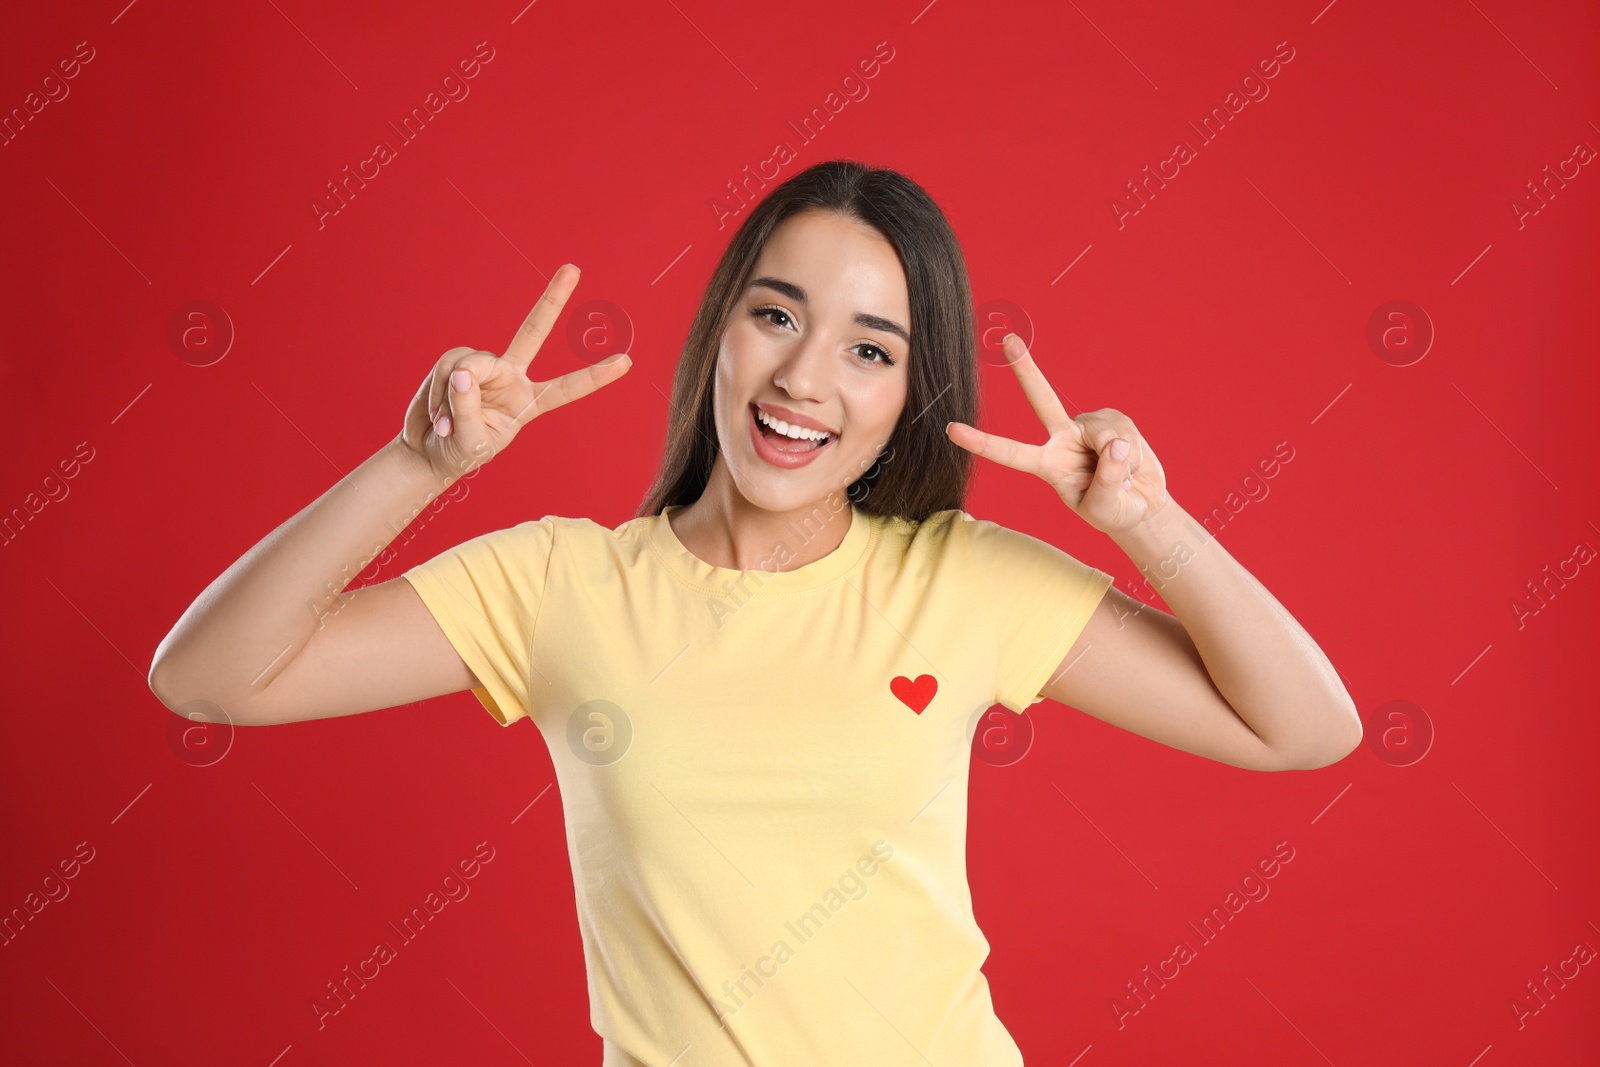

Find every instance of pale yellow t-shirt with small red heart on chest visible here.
[403,498,1112,1067]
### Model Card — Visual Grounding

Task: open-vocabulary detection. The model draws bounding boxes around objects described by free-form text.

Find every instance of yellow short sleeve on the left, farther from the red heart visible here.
[402,517,555,726]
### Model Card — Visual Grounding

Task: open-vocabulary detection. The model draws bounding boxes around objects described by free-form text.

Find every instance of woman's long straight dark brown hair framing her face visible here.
[638,160,979,522]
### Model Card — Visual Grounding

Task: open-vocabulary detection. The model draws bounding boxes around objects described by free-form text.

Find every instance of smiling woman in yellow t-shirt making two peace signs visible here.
[150,162,1362,1067]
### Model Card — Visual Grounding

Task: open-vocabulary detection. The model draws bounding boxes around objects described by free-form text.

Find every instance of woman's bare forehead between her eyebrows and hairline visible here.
[752,211,910,313]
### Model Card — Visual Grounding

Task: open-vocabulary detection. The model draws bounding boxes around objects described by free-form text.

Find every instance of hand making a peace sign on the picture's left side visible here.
[400,264,632,482]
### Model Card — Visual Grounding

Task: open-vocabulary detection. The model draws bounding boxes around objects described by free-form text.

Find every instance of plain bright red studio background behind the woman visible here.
[0,0,1600,1067]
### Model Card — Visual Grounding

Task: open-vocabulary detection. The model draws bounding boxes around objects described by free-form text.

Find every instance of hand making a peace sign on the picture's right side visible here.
[946,333,1171,537]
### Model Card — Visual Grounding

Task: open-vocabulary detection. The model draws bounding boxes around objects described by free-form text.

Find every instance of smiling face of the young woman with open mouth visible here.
[714,211,910,512]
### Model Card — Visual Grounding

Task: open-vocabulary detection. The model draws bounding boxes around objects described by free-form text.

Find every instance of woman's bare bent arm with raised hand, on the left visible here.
[149,264,629,735]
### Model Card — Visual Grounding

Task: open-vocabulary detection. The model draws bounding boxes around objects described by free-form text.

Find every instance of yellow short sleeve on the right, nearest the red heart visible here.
[962,518,1112,715]
